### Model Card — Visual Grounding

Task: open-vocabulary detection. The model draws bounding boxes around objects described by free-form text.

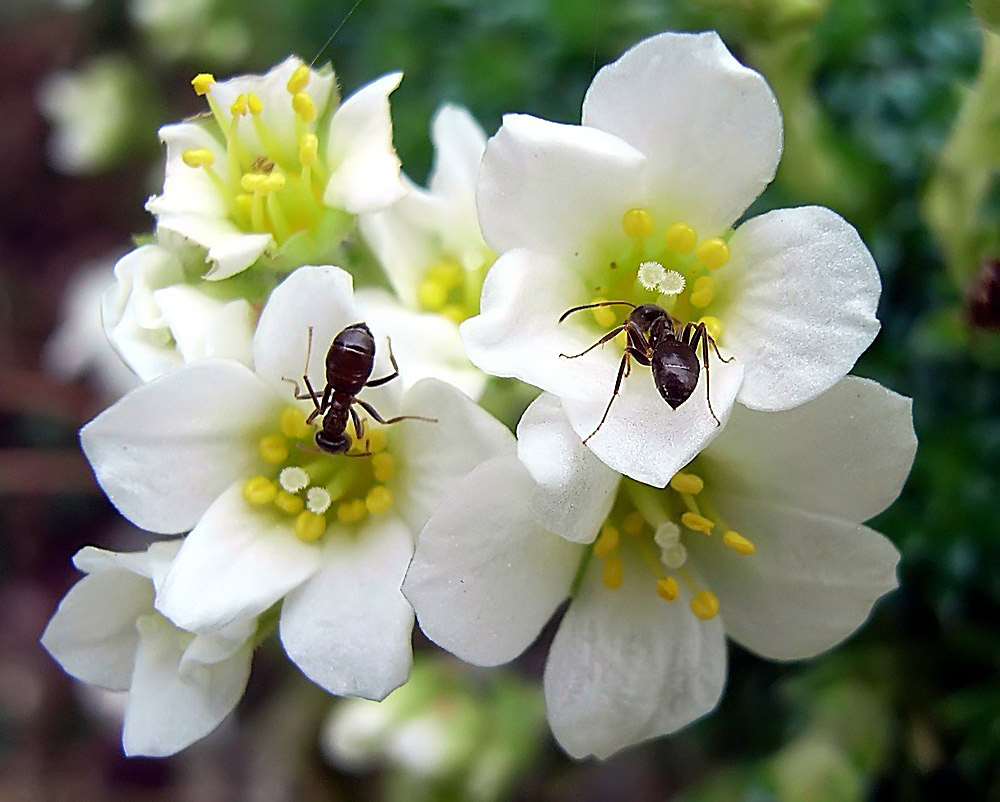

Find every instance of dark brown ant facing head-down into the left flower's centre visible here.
[284,323,437,457]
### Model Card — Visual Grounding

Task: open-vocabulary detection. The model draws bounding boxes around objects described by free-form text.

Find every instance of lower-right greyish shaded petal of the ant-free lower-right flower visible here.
[686,497,899,660]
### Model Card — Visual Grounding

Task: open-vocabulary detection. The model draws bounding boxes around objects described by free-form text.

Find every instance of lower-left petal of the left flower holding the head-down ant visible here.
[156,482,321,632]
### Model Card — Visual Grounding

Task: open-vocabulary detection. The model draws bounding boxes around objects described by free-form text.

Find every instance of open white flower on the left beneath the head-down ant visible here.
[81,267,513,698]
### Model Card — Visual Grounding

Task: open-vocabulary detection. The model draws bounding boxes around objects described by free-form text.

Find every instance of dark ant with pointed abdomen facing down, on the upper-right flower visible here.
[559,301,735,443]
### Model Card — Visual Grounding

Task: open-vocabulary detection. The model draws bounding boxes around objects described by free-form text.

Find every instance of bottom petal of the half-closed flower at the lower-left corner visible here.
[122,614,253,757]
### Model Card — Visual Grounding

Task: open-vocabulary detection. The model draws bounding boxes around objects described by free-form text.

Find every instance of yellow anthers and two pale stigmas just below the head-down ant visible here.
[243,407,396,543]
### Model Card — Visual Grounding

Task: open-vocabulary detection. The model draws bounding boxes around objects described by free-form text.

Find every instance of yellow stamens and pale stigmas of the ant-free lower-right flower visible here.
[591,472,756,621]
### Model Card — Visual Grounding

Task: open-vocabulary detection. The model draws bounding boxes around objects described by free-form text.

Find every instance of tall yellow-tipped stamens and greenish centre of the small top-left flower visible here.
[181,64,328,244]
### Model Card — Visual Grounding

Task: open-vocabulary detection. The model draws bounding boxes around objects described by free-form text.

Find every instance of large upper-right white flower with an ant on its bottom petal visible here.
[462,33,879,487]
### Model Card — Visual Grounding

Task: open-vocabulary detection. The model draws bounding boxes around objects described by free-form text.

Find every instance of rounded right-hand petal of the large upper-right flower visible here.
[724,206,881,410]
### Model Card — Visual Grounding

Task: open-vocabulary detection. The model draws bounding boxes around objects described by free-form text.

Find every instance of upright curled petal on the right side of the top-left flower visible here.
[323,72,406,214]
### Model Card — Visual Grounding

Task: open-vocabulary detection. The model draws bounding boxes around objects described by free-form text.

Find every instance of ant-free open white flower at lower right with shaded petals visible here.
[403,378,916,757]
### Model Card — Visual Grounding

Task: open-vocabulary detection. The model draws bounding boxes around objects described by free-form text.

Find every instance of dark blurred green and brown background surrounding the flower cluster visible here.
[0,0,1000,800]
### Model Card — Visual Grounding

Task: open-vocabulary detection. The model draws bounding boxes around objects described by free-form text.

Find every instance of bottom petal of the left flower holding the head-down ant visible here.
[280,517,413,700]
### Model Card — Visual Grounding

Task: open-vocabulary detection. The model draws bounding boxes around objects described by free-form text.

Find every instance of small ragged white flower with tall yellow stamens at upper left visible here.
[146,57,406,280]
